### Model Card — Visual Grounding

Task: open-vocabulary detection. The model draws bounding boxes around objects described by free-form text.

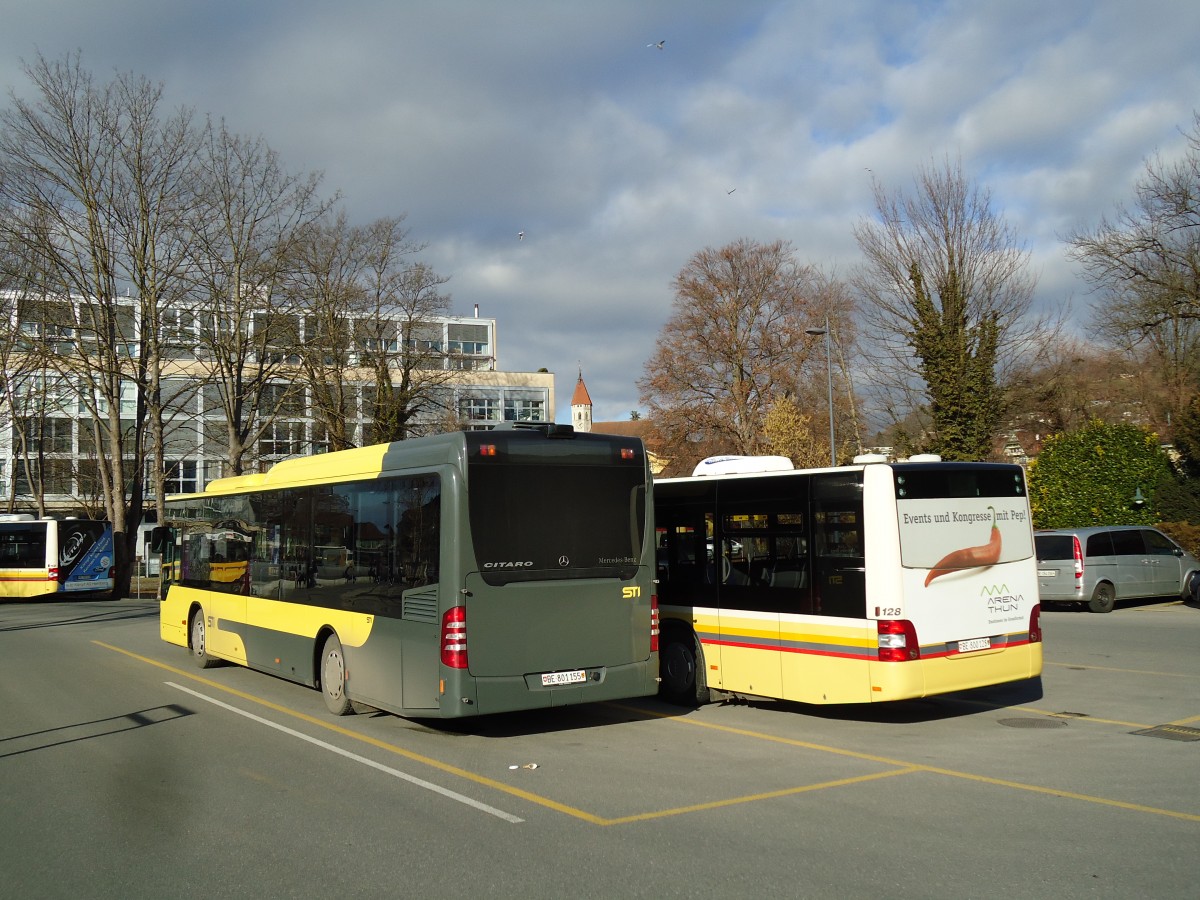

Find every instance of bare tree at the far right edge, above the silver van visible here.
[1068,113,1200,421]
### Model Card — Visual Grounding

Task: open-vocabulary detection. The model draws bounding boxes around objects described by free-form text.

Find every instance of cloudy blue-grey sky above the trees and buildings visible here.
[0,0,1200,421]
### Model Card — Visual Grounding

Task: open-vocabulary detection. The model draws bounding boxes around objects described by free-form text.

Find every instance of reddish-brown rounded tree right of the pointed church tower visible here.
[637,239,850,480]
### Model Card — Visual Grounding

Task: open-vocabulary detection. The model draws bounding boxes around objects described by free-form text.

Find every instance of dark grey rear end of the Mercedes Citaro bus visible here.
[443,428,658,713]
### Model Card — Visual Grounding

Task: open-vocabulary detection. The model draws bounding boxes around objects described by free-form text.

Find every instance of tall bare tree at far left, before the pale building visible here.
[0,54,194,595]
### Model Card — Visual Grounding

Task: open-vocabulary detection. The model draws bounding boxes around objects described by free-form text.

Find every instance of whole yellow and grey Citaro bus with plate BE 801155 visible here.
[155,425,659,718]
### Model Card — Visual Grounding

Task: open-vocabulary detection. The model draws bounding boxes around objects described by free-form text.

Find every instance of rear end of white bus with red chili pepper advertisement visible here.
[864,462,1042,698]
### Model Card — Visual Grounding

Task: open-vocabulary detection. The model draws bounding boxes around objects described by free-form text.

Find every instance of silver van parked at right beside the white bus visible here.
[1033,526,1200,612]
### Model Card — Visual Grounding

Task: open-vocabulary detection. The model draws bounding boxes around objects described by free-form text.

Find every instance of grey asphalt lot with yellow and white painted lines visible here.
[0,600,1200,900]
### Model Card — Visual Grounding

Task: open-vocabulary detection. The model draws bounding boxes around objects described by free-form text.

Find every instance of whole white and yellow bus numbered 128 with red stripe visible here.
[654,456,1042,703]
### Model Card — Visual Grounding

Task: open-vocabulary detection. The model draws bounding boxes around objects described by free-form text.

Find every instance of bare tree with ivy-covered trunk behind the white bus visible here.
[854,161,1048,458]
